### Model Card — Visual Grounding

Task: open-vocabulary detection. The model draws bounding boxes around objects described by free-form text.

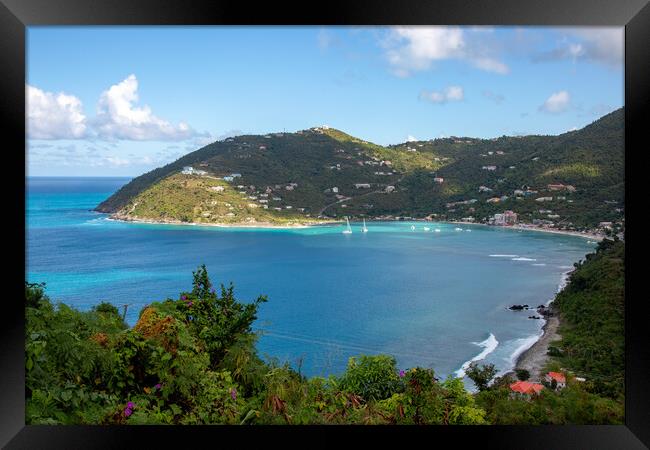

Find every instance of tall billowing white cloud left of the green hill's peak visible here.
[94,75,199,141]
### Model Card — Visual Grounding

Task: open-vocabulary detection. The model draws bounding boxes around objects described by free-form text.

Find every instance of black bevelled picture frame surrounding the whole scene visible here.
[0,0,650,450]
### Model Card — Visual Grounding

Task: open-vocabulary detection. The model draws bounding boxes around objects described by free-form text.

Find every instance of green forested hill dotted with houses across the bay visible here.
[97,108,624,229]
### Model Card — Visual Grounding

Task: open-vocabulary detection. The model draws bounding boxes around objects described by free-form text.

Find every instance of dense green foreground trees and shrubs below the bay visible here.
[25,240,624,424]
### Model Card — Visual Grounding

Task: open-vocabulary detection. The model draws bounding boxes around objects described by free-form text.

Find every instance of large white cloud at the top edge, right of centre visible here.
[382,26,509,77]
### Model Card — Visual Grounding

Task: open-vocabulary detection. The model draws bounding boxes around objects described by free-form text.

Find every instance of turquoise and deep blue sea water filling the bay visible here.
[26,177,594,384]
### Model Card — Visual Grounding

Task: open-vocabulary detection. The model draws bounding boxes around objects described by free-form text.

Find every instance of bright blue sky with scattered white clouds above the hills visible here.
[25,26,624,176]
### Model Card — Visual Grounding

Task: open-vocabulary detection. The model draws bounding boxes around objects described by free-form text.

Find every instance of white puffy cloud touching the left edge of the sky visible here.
[26,85,87,139]
